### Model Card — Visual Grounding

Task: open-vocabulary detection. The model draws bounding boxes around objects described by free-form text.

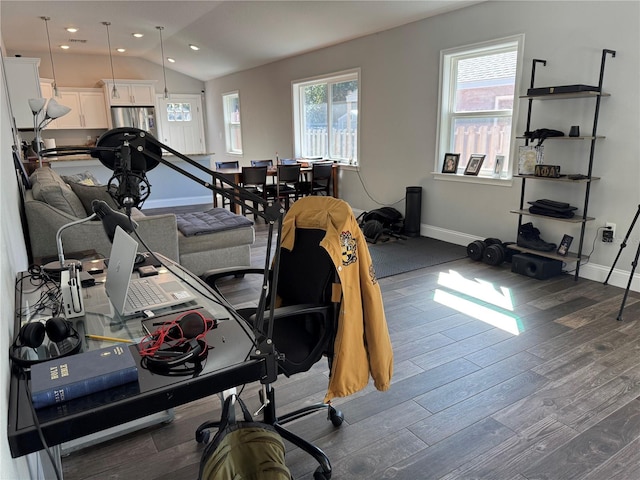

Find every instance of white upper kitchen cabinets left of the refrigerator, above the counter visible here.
[49,88,109,129]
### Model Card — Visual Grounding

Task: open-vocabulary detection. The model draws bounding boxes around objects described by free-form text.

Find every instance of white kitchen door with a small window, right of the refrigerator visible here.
[156,94,206,155]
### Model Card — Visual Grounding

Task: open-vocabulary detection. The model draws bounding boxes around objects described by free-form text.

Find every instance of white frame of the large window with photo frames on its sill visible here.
[434,34,524,184]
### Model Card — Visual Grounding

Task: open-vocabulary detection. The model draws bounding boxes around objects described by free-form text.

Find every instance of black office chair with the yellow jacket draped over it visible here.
[196,228,344,480]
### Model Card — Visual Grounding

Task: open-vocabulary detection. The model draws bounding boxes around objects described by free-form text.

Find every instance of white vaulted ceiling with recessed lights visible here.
[0,0,480,81]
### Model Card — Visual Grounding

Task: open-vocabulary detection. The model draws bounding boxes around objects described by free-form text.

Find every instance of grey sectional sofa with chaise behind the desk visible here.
[25,167,255,275]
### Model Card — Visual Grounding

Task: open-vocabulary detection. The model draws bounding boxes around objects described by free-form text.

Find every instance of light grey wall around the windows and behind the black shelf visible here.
[206,1,640,286]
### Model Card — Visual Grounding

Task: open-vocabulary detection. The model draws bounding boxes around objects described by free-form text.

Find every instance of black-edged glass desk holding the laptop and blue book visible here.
[7,256,266,458]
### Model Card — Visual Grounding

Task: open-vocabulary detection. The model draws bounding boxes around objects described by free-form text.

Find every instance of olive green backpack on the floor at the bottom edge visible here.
[198,395,293,480]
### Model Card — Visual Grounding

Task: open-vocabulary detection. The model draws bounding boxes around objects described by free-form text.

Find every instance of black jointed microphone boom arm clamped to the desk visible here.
[42,127,284,384]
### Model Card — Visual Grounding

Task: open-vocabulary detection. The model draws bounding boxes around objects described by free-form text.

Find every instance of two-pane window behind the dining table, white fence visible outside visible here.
[293,70,360,164]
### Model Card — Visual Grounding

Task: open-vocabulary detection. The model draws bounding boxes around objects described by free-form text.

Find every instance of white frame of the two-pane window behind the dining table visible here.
[291,68,362,165]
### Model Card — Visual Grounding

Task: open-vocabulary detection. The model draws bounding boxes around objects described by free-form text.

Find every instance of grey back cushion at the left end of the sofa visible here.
[30,167,86,218]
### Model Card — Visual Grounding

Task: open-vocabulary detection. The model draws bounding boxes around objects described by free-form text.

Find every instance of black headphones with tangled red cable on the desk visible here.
[139,311,216,374]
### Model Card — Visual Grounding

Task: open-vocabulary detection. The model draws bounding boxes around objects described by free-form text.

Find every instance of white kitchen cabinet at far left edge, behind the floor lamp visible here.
[4,57,41,129]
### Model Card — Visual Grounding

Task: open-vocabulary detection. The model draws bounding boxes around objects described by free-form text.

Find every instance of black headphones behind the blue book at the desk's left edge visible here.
[9,317,82,368]
